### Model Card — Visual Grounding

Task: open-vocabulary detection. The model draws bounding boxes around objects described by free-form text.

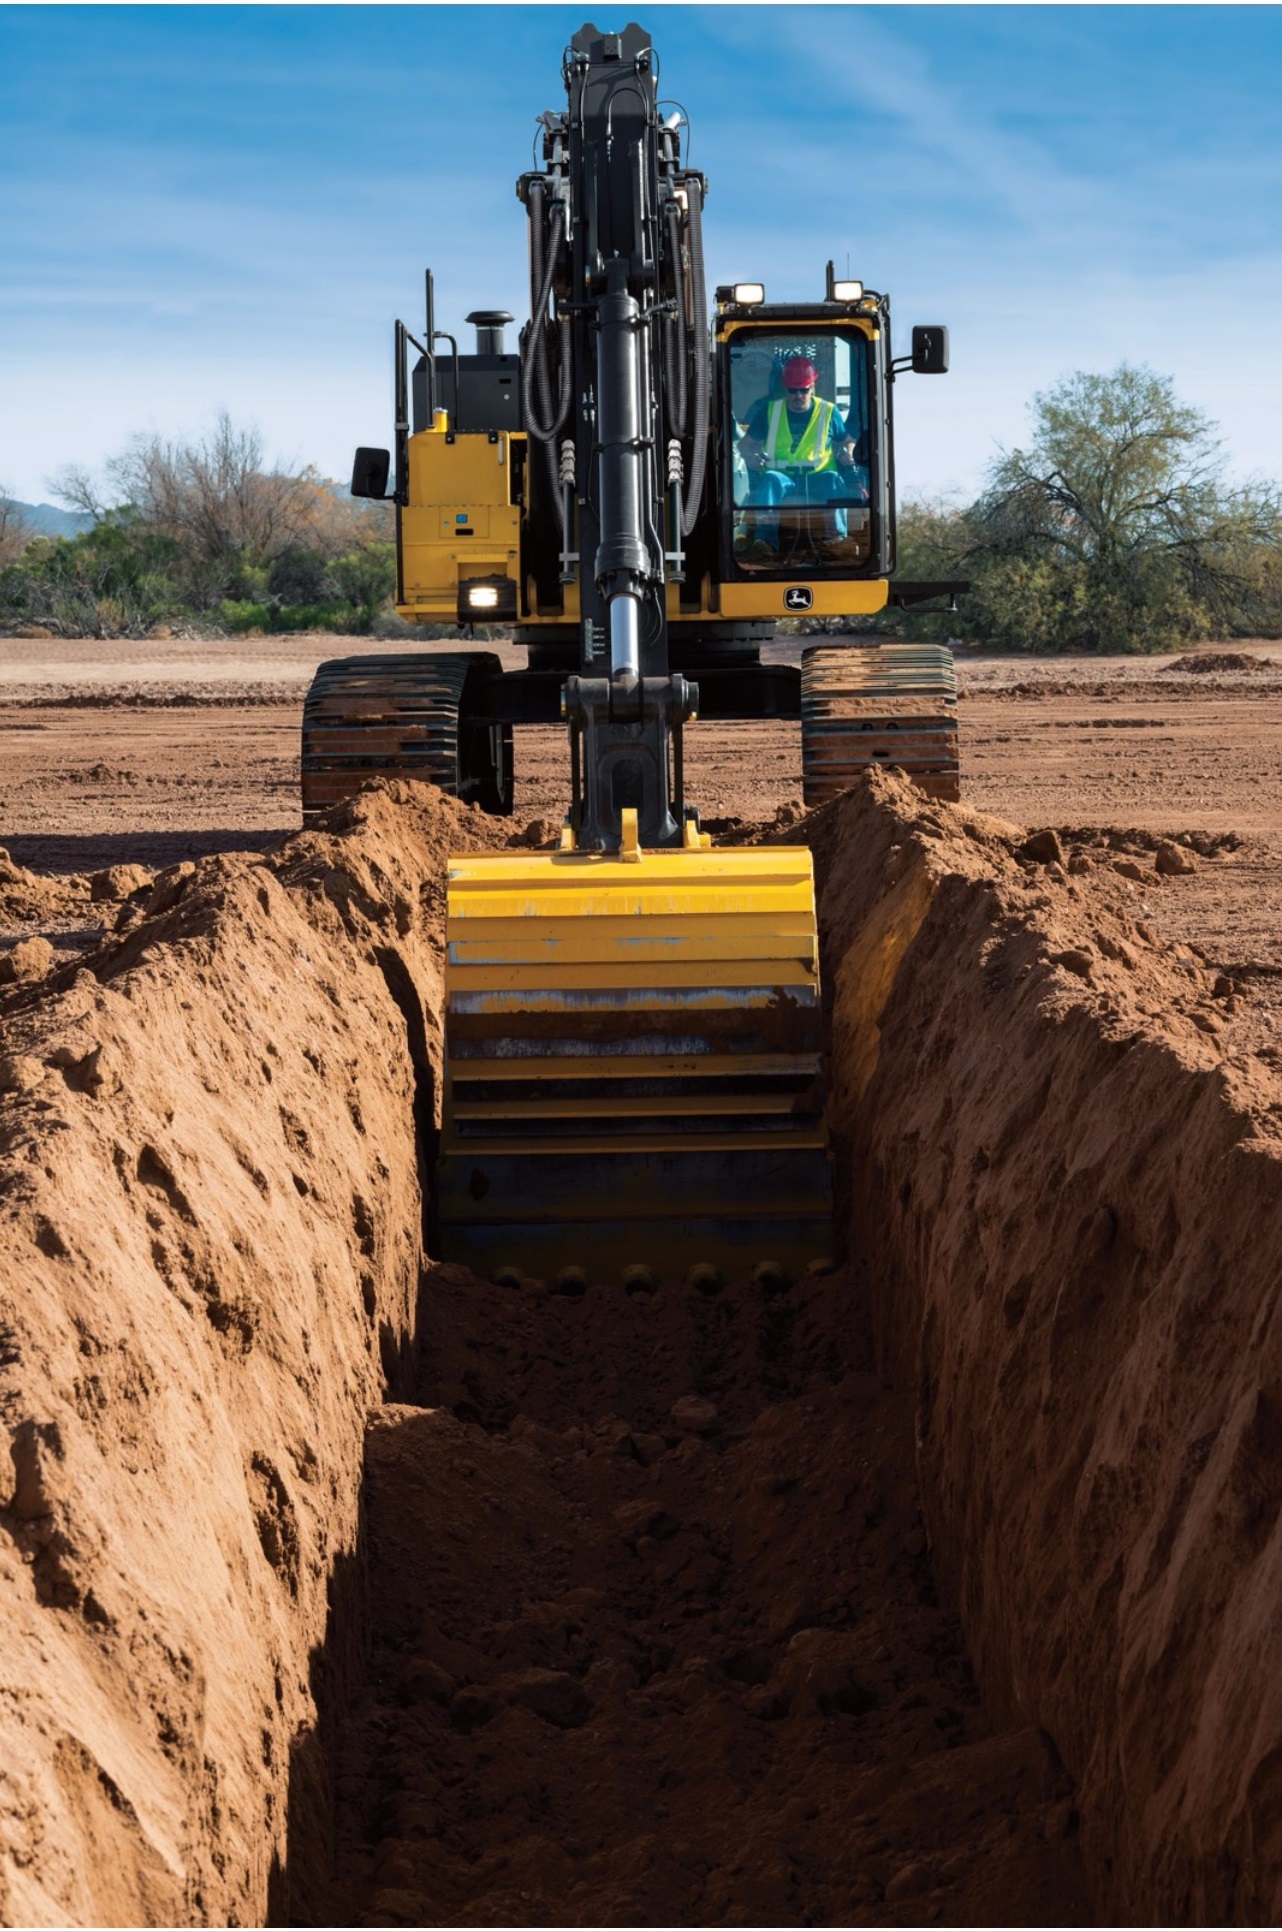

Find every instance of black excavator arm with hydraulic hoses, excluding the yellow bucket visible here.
[517,25,709,852]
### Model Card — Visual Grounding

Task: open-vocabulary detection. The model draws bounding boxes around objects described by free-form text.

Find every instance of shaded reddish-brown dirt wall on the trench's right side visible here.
[811,782,1282,1923]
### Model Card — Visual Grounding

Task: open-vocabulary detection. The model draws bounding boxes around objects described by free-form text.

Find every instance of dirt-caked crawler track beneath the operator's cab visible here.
[801,643,962,805]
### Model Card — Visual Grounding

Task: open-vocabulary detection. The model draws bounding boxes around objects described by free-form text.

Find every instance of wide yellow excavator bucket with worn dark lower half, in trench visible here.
[436,840,832,1280]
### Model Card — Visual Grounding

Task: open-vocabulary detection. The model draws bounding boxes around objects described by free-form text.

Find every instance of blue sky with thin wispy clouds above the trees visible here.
[0,0,1282,502]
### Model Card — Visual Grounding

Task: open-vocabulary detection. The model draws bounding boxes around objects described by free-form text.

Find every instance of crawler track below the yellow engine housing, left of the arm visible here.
[303,653,474,819]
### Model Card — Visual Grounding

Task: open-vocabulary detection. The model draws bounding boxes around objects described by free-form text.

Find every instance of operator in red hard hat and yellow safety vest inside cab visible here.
[736,355,869,558]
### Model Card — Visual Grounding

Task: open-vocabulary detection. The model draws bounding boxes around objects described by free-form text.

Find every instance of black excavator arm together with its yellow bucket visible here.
[438,25,832,1282]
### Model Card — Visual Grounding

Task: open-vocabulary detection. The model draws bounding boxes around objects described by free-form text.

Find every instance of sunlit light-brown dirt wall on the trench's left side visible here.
[0,780,486,1923]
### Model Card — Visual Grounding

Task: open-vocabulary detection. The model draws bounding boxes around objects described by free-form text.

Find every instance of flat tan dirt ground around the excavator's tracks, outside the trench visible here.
[0,637,1282,1047]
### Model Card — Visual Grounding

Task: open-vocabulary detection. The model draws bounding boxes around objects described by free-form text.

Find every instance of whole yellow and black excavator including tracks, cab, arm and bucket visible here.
[303,25,960,1286]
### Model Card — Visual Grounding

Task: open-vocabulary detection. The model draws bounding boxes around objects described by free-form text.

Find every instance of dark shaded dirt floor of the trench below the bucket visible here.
[272,783,1095,1923]
